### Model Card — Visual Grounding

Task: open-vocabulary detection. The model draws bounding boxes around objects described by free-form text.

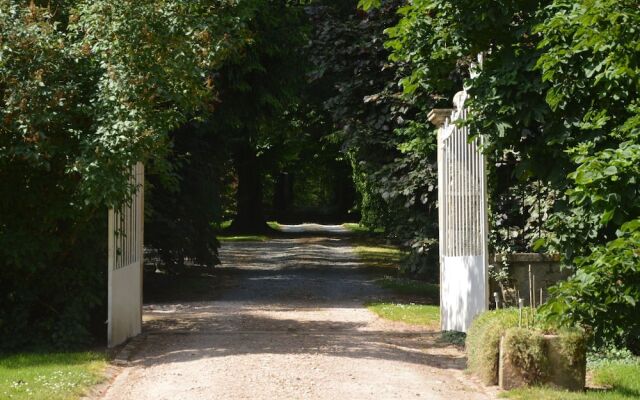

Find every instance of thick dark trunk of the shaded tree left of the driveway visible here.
[228,146,271,233]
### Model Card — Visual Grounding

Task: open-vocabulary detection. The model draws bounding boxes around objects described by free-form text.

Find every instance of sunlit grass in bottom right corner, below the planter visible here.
[501,361,640,400]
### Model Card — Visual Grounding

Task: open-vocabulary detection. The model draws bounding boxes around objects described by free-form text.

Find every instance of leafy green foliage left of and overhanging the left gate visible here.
[0,0,242,347]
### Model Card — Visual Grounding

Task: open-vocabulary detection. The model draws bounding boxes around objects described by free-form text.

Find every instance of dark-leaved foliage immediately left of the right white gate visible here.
[309,1,437,279]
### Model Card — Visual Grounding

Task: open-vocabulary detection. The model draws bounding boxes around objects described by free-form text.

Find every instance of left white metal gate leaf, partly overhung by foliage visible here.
[107,163,144,347]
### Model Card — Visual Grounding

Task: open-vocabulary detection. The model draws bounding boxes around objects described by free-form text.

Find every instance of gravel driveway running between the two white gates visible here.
[104,227,491,400]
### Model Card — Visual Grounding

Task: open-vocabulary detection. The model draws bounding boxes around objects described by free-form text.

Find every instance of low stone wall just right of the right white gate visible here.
[489,253,570,307]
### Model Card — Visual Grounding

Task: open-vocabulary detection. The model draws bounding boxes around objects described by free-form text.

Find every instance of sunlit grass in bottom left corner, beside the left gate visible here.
[0,352,107,400]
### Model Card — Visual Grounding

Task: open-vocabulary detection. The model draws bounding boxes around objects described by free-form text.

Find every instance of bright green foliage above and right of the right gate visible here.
[376,0,640,350]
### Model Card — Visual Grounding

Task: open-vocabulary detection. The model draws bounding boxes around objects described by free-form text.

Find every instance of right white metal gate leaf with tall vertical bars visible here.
[438,92,489,332]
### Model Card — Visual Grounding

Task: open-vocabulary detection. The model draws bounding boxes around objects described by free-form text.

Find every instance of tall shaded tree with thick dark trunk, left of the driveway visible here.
[211,0,306,232]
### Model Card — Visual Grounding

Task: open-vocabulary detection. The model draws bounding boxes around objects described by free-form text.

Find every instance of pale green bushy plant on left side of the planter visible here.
[465,308,518,385]
